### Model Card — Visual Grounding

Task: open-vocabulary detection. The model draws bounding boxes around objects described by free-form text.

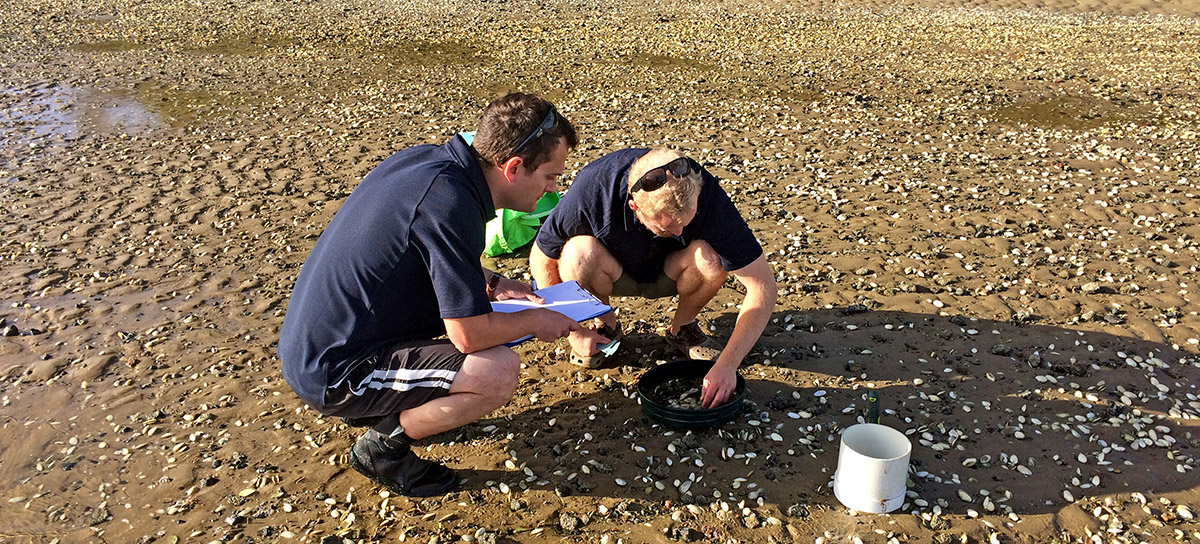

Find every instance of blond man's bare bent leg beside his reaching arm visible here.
[666,240,728,334]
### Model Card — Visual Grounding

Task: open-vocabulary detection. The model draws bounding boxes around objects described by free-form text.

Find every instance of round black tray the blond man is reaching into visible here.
[637,359,746,429]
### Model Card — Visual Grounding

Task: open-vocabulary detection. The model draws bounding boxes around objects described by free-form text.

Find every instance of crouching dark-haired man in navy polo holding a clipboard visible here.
[278,94,600,496]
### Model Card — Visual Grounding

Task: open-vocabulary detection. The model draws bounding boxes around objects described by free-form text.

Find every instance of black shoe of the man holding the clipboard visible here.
[350,429,458,497]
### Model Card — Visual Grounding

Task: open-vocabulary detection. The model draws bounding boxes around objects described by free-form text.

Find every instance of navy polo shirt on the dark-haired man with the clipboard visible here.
[278,136,496,406]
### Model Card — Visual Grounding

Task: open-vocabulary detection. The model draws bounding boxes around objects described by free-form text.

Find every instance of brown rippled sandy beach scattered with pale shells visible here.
[0,0,1200,544]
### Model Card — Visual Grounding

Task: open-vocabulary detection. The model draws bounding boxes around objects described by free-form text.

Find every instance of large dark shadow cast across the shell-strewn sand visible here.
[429,310,1200,523]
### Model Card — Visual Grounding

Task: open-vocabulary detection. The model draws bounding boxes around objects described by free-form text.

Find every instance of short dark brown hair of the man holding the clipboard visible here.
[472,92,580,171]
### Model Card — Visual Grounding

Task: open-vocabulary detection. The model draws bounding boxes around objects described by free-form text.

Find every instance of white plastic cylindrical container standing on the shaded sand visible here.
[833,423,912,514]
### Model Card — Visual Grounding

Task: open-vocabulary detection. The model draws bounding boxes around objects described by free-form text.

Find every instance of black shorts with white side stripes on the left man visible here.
[320,340,467,435]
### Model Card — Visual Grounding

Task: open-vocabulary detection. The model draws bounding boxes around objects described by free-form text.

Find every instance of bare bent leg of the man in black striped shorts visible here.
[400,346,521,440]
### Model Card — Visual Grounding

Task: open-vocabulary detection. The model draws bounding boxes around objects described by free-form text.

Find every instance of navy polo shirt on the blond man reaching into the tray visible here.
[538,149,762,283]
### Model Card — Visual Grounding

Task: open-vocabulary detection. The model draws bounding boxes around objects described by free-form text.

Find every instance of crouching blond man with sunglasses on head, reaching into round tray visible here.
[529,149,778,408]
